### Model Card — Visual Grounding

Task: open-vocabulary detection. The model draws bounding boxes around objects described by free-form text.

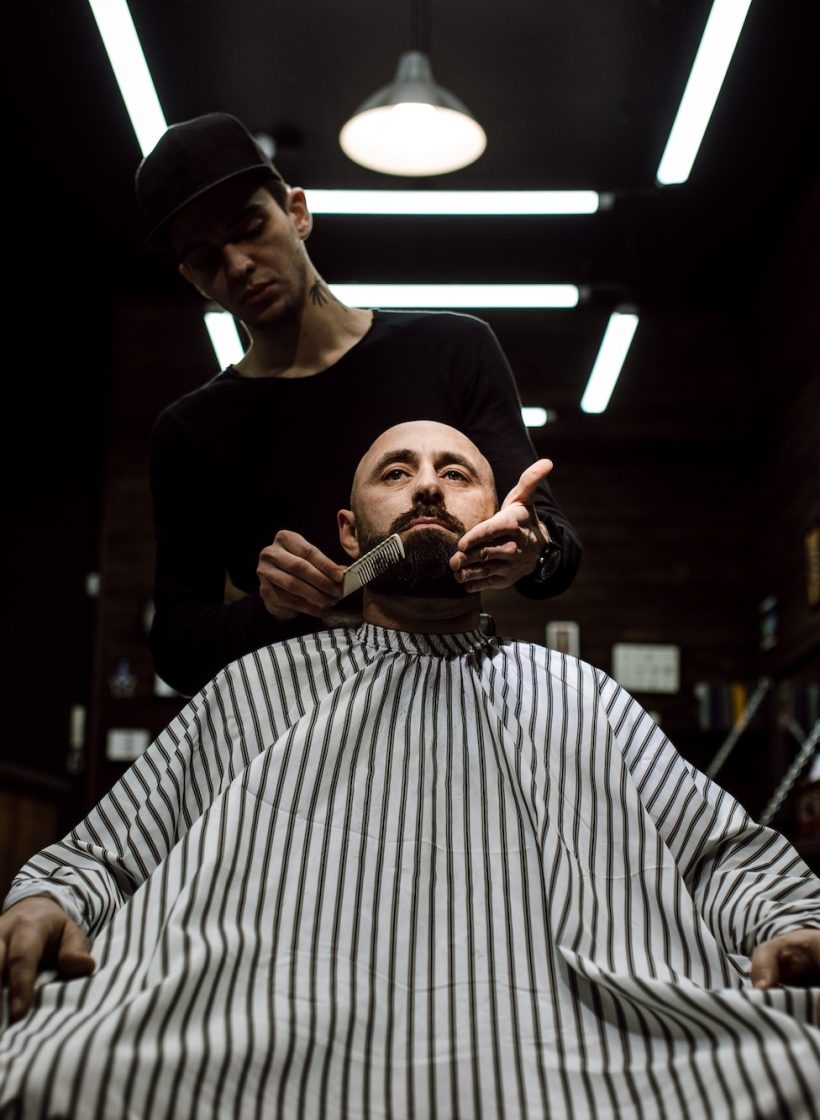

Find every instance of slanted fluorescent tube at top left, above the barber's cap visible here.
[88,0,167,156]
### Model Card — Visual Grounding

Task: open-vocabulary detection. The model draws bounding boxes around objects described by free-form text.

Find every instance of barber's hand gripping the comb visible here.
[257,529,345,619]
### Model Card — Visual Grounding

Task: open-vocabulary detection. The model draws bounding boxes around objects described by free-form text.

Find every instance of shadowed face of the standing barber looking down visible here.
[169,179,310,327]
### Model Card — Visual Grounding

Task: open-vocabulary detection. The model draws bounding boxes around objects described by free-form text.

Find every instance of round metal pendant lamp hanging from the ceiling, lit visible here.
[338,50,487,175]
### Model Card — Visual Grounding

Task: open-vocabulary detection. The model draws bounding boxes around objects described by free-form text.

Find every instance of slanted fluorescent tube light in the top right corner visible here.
[655,0,752,185]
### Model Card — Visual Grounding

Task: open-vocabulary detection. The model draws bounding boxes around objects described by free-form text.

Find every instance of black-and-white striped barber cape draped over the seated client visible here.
[0,625,820,1120]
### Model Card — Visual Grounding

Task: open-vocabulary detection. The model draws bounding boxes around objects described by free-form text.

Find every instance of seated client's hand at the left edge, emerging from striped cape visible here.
[0,896,94,1023]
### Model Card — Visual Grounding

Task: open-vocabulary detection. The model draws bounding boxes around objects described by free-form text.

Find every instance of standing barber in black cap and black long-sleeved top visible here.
[136,113,581,694]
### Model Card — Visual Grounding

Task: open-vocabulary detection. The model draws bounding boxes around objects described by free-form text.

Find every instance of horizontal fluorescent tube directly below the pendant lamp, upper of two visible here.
[307,189,600,215]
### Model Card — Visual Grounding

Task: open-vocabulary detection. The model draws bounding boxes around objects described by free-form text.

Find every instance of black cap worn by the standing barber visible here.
[134,113,285,246]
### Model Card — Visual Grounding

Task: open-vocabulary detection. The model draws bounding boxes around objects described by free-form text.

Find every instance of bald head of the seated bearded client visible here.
[339,421,496,595]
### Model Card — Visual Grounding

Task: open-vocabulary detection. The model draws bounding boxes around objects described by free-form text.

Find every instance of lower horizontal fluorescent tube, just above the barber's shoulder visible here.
[328,283,578,308]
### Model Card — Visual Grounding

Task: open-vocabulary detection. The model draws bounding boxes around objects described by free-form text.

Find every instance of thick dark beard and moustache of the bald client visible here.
[356,505,469,599]
